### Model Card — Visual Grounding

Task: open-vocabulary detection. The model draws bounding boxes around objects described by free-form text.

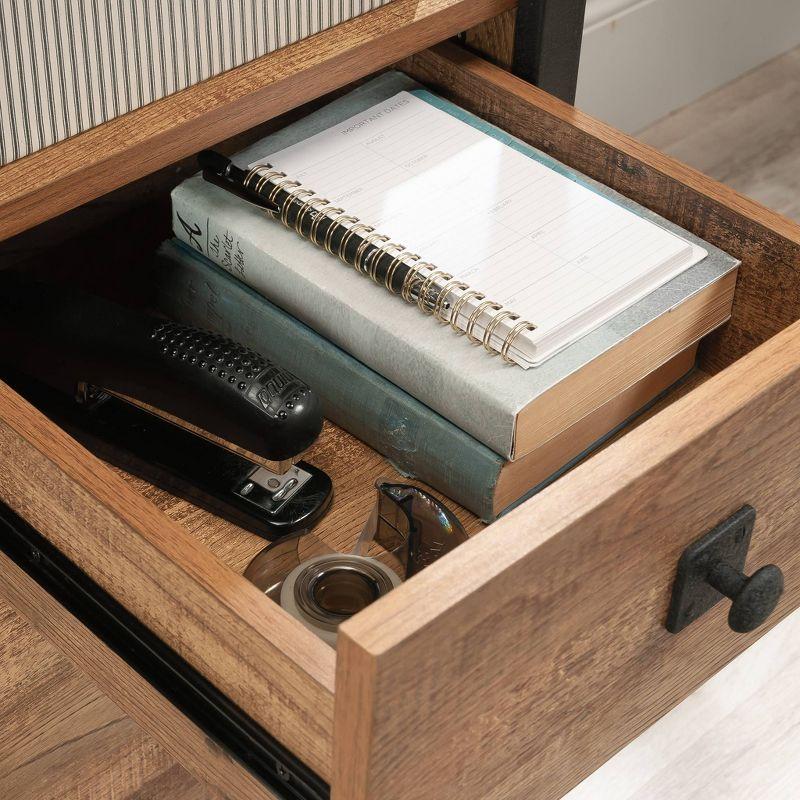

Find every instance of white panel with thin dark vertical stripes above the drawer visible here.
[0,0,389,164]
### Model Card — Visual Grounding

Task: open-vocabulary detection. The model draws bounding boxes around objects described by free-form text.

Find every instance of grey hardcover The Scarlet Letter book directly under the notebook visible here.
[172,72,738,459]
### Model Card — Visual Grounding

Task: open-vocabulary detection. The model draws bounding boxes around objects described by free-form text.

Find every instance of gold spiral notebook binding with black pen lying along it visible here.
[200,151,536,364]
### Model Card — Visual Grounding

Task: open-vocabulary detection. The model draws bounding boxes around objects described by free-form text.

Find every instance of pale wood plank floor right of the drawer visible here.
[564,43,800,800]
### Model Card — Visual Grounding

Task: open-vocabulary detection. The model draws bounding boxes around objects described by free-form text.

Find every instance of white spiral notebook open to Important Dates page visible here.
[239,91,706,368]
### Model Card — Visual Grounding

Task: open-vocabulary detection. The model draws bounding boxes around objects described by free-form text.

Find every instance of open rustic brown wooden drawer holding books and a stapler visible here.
[0,45,800,800]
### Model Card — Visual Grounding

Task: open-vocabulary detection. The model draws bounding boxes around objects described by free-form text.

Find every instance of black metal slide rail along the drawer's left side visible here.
[0,502,330,800]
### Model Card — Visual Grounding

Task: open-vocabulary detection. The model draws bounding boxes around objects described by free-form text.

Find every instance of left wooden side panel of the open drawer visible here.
[0,383,334,780]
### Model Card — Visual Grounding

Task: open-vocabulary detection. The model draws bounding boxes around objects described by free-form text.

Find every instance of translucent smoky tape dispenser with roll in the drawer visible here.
[244,482,467,645]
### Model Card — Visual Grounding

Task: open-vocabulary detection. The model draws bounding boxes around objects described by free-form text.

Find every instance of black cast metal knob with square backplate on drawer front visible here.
[667,506,783,633]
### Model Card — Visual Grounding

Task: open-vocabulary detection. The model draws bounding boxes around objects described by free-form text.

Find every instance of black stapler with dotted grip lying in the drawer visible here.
[0,275,332,539]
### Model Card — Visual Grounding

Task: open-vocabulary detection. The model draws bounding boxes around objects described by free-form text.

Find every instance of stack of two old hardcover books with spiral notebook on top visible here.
[156,72,738,520]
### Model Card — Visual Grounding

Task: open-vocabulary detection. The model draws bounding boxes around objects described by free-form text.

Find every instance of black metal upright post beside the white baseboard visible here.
[511,0,586,103]
